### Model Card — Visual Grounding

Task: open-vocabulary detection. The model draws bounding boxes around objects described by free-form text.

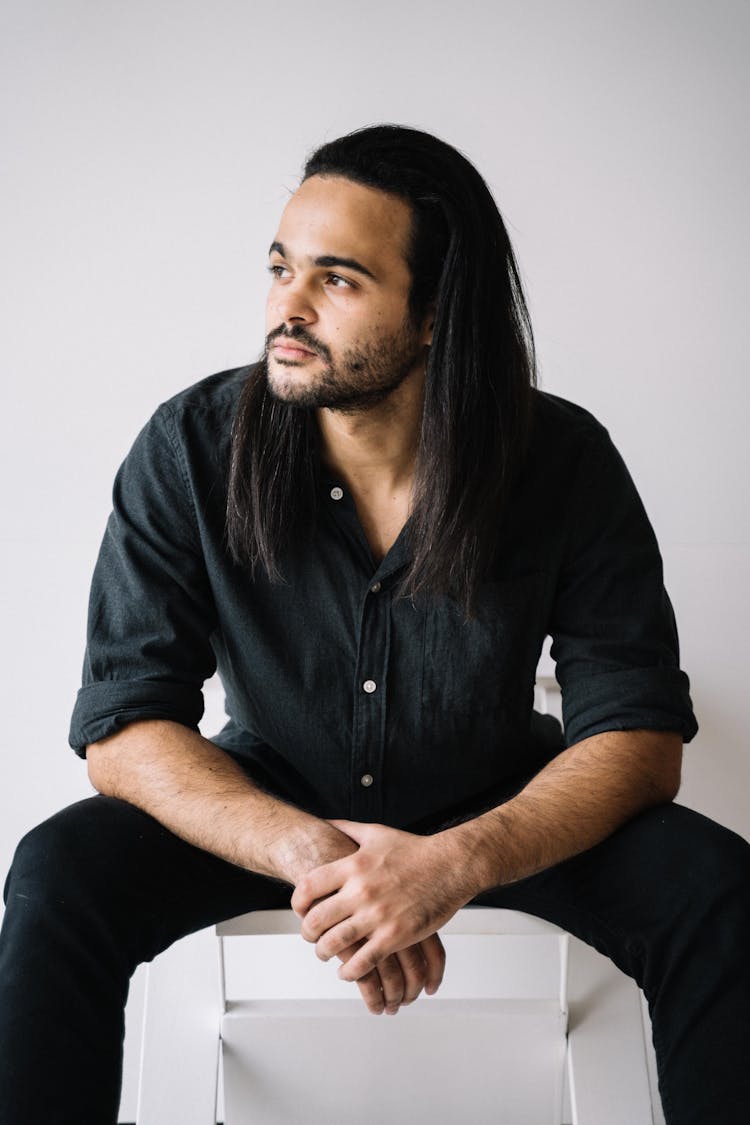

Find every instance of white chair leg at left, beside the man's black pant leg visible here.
[136,927,222,1125]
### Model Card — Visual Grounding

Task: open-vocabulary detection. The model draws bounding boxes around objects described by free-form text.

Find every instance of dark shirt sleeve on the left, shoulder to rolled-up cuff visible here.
[69,406,216,756]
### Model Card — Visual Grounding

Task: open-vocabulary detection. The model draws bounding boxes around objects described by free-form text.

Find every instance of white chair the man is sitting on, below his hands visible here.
[137,907,653,1125]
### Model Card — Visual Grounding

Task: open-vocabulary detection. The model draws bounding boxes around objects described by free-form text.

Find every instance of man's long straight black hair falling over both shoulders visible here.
[226,125,536,612]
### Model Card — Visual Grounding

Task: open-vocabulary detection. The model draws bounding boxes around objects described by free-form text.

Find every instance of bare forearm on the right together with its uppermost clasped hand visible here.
[292,730,683,980]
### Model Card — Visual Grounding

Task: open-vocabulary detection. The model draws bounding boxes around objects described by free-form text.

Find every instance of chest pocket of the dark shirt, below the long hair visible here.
[422,570,549,717]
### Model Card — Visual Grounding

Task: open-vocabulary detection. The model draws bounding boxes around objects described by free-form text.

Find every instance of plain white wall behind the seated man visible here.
[0,0,750,1116]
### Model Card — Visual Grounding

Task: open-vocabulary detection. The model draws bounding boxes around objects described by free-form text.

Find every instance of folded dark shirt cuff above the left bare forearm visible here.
[67,680,204,757]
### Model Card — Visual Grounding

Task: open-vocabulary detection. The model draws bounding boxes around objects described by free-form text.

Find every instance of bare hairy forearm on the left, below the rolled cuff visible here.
[87,720,356,885]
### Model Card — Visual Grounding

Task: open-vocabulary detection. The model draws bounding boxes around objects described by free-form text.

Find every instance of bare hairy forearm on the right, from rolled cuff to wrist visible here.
[442,730,683,894]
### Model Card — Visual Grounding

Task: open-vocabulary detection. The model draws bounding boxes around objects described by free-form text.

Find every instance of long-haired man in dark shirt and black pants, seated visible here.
[0,126,750,1125]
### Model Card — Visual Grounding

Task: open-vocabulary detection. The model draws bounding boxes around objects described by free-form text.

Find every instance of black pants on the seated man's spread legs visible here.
[0,797,750,1125]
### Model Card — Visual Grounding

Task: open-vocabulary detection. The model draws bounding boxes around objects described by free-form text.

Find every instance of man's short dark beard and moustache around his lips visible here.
[263,325,424,414]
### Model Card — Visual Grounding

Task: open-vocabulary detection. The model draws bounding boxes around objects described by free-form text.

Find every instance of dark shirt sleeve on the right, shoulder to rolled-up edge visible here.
[550,429,697,746]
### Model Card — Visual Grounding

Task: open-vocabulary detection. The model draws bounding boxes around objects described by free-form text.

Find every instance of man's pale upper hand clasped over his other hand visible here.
[291,820,475,991]
